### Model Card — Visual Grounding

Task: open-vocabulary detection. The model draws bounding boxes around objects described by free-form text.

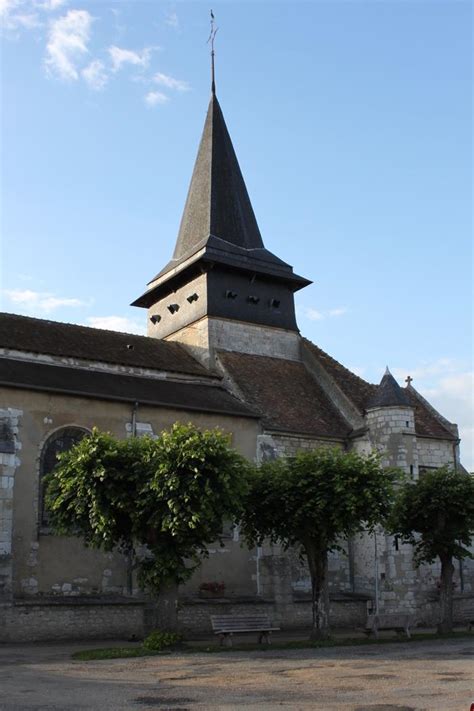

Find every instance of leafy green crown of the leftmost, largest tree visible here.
[45,424,251,593]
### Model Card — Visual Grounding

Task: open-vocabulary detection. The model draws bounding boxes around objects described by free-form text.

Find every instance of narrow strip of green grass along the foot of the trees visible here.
[72,632,473,662]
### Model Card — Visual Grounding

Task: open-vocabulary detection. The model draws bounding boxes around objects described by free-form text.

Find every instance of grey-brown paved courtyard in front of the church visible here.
[0,638,474,711]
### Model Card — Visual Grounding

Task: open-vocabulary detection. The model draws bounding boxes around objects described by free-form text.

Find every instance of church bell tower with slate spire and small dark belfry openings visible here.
[132,64,311,361]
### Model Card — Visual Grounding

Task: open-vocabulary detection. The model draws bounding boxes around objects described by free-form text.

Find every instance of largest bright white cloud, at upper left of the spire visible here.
[45,10,93,81]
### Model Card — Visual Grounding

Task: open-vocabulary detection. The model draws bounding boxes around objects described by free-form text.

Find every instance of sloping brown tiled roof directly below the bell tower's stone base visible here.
[219,351,350,439]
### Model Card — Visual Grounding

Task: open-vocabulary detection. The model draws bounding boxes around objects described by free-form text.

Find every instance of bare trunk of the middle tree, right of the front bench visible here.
[305,543,330,640]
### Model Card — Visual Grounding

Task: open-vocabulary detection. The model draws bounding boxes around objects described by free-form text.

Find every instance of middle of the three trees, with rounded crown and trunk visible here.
[242,447,393,639]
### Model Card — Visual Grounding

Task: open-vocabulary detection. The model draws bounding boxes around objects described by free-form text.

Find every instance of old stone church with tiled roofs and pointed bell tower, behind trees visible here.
[0,80,474,641]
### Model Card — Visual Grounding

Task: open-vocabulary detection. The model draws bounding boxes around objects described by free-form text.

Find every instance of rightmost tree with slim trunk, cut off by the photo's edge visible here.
[390,466,474,633]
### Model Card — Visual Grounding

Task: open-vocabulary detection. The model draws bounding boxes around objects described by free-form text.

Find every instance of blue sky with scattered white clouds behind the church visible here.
[0,0,474,470]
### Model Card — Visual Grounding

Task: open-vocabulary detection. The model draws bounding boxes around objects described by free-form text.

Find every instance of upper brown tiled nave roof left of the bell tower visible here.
[0,313,209,377]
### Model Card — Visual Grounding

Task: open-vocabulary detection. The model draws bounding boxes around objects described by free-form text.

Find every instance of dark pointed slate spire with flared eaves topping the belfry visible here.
[132,48,311,307]
